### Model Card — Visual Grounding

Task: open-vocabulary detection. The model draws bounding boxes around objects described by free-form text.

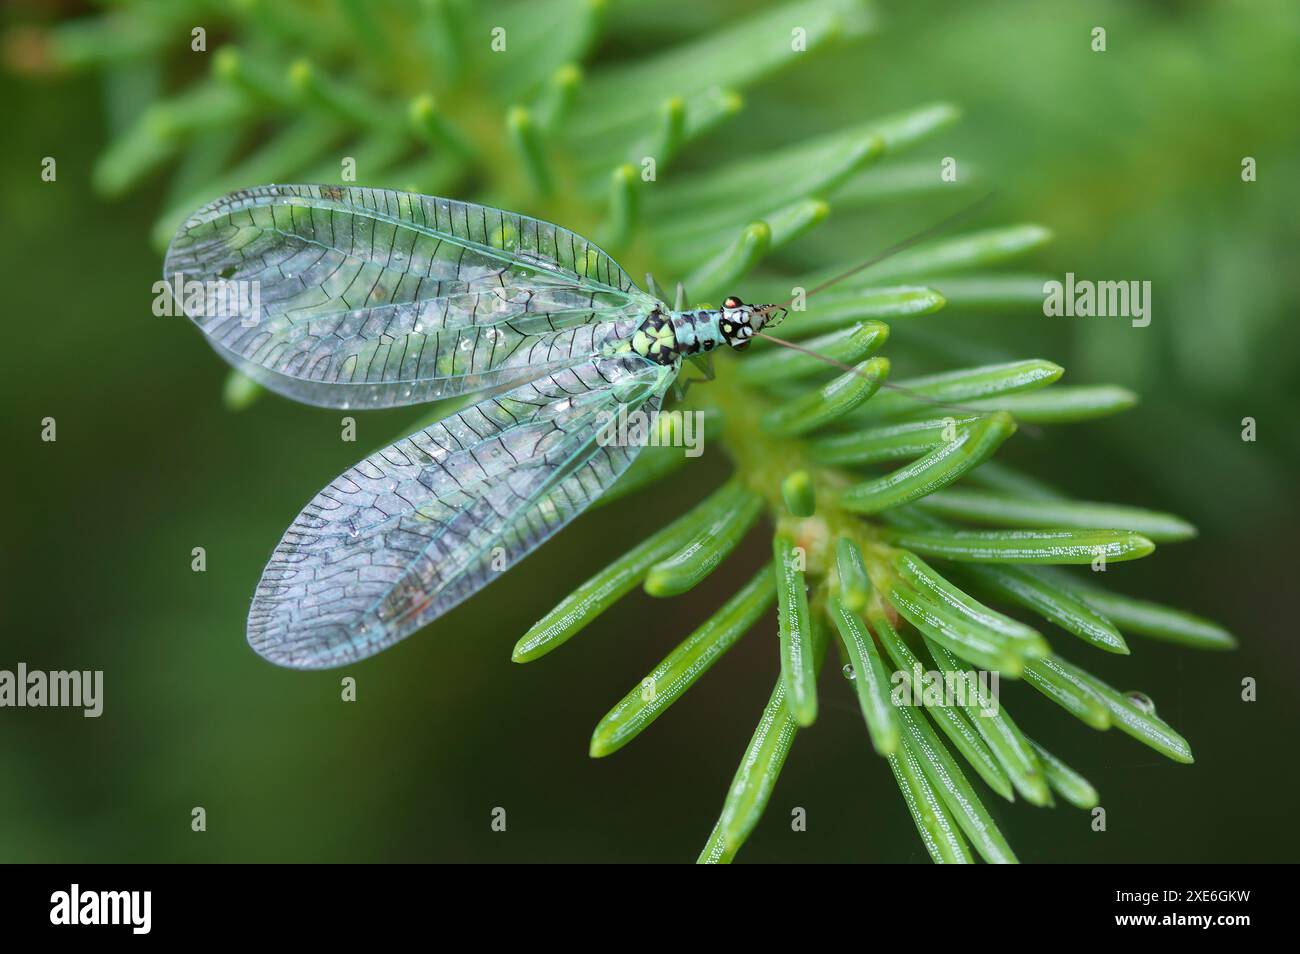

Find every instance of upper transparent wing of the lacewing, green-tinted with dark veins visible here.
[164,186,654,408]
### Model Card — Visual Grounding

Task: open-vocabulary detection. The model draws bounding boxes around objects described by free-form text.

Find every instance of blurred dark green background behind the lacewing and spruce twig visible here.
[0,1,1300,862]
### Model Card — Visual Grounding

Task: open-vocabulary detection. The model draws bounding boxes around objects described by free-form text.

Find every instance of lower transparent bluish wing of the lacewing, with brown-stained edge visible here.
[248,355,676,669]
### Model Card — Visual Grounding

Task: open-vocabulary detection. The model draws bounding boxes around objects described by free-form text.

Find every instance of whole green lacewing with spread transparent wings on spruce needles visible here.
[164,185,977,669]
